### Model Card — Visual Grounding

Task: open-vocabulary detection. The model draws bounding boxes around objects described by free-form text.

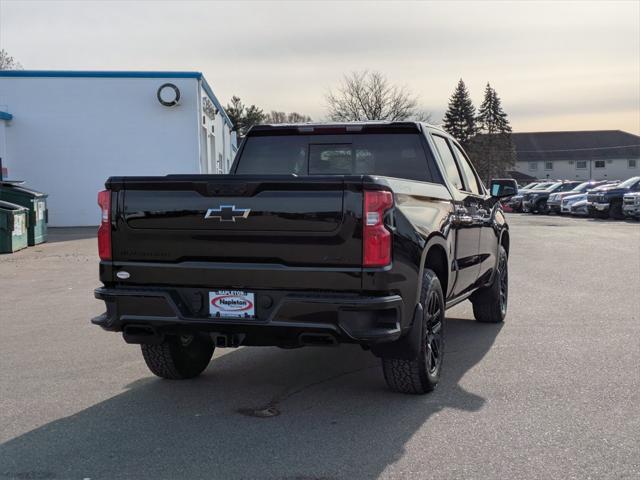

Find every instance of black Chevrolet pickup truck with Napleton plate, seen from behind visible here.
[92,122,516,393]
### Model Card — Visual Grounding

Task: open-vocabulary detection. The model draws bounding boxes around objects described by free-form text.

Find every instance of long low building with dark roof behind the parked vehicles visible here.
[511,130,640,180]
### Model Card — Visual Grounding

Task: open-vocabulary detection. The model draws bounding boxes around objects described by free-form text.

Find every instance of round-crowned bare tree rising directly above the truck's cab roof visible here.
[326,70,421,121]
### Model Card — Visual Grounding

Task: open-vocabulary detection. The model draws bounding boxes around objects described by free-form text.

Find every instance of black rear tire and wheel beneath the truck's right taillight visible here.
[382,269,445,394]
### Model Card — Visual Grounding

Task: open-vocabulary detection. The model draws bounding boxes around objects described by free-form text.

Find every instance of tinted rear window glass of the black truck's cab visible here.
[235,133,436,182]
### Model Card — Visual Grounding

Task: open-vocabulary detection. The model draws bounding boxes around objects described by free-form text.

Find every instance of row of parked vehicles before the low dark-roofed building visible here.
[504,177,640,220]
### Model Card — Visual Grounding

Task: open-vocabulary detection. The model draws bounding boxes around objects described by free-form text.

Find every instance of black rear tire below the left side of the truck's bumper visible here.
[140,334,215,380]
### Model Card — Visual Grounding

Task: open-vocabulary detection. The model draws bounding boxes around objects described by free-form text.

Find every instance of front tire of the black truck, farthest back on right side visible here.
[471,245,509,323]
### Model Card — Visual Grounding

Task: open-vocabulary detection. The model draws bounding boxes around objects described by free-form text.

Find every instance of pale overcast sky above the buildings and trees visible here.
[0,0,640,133]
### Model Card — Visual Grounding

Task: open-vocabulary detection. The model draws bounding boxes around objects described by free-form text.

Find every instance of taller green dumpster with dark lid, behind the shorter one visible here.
[0,182,49,246]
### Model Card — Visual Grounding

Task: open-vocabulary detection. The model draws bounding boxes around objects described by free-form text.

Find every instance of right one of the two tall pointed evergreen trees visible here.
[467,83,516,182]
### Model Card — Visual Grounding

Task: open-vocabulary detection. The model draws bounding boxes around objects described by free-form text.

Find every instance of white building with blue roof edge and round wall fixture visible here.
[0,70,237,226]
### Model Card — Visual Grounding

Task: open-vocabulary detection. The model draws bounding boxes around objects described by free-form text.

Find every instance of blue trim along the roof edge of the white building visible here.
[0,70,233,128]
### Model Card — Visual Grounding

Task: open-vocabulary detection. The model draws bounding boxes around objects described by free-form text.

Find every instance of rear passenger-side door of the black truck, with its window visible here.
[431,134,482,296]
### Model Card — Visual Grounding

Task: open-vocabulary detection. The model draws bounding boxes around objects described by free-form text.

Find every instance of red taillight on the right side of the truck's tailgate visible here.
[362,190,393,267]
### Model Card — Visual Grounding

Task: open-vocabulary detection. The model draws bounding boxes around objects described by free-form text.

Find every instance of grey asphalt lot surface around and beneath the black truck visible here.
[0,215,640,480]
